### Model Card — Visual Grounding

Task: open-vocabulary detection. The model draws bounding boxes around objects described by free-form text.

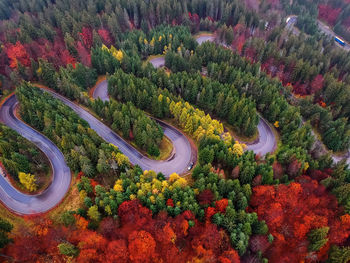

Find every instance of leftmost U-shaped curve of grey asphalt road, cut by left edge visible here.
[0,95,71,215]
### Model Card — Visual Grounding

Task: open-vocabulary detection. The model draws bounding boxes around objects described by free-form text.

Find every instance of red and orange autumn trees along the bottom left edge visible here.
[6,199,240,263]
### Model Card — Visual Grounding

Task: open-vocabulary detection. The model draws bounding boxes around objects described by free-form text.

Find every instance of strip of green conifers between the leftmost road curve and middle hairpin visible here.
[16,83,129,177]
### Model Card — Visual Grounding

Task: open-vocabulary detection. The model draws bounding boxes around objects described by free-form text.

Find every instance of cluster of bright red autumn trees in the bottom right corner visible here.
[251,175,350,262]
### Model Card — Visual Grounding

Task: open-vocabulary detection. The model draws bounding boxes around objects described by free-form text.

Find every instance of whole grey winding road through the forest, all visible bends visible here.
[0,32,276,215]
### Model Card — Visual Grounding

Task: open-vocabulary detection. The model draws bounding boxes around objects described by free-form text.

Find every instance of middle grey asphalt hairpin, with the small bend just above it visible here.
[49,88,196,176]
